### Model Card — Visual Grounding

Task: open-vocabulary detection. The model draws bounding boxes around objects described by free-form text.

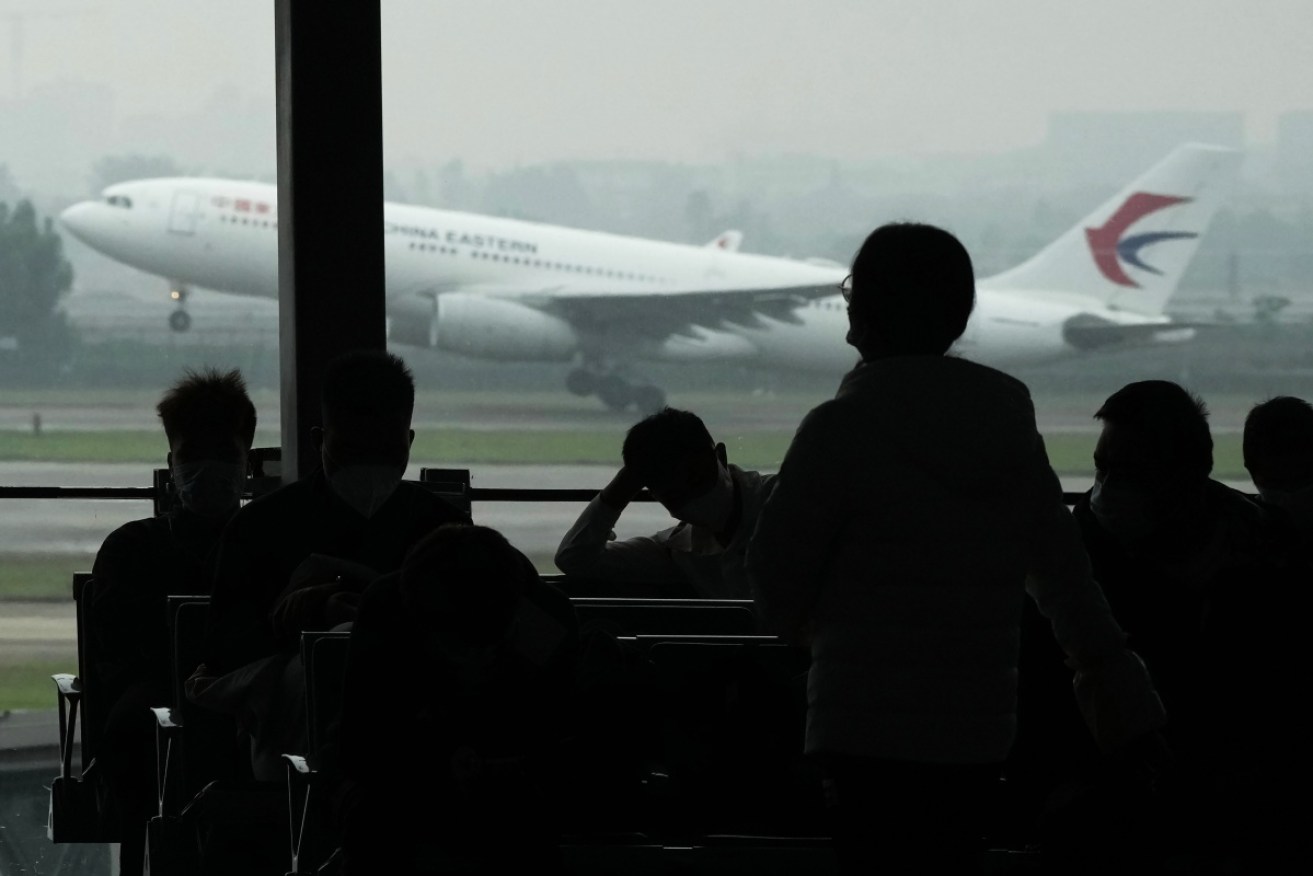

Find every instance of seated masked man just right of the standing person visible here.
[1075,381,1308,855]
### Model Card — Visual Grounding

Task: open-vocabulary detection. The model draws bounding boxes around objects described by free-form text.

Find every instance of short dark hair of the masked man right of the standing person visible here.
[1094,380,1213,479]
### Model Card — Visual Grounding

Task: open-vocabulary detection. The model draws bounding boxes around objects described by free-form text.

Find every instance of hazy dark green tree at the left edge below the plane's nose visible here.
[0,201,74,372]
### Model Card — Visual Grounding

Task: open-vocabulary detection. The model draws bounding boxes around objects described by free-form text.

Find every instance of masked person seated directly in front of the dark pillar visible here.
[189,351,467,777]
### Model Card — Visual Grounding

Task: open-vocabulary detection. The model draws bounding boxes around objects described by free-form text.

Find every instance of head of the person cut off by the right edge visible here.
[1245,395,1313,498]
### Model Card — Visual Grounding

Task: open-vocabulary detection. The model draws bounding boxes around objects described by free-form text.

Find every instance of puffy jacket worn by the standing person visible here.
[747,356,1162,763]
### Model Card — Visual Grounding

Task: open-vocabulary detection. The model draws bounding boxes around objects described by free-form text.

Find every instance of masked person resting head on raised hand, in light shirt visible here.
[555,407,775,599]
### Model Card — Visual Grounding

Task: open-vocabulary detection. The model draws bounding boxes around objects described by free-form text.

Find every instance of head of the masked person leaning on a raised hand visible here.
[621,407,734,532]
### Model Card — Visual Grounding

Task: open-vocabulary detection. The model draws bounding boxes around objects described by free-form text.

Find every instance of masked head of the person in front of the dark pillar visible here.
[311,349,415,517]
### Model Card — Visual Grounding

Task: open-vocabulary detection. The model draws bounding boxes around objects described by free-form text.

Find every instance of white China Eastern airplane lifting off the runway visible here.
[60,144,1239,412]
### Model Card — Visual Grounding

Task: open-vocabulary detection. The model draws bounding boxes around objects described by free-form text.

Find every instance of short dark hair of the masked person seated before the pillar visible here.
[320,349,415,424]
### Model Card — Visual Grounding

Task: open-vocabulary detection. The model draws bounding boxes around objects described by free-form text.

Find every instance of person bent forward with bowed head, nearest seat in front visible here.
[328,525,579,873]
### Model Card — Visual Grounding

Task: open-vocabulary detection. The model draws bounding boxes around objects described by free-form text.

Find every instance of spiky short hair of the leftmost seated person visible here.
[155,368,256,450]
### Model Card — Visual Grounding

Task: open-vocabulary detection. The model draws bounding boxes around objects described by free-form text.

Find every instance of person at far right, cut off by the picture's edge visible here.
[1243,395,1313,551]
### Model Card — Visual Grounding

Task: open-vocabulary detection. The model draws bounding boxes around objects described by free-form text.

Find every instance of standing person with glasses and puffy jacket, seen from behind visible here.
[747,225,1162,873]
